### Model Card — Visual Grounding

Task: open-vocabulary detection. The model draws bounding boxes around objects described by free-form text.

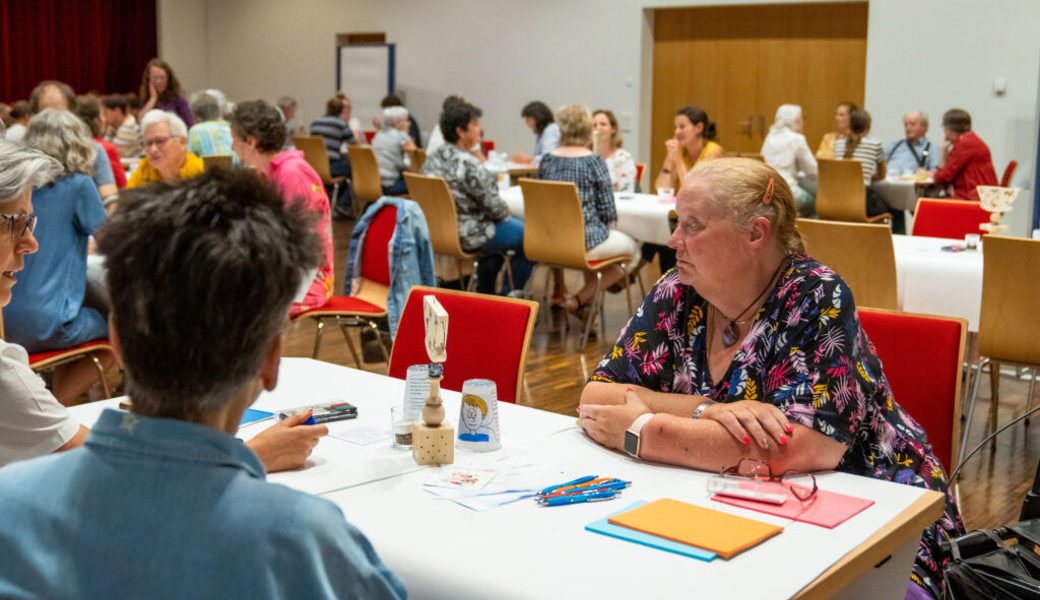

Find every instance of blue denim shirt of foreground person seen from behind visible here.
[0,410,405,599]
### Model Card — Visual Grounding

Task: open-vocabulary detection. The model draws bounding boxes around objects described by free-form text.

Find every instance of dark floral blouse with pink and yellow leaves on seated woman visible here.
[590,255,964,586]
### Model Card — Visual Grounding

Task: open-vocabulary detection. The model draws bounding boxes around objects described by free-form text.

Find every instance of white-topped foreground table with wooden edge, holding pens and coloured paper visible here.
[72,358,942,598]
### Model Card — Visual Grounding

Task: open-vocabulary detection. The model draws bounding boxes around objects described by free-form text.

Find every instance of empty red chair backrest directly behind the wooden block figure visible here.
[390,286,538,402]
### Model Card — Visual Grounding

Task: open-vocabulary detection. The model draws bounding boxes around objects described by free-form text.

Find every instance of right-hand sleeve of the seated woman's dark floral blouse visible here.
[766,269,880,446]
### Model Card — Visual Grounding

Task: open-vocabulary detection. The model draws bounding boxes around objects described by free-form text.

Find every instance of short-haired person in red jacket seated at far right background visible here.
[917,108,998,202]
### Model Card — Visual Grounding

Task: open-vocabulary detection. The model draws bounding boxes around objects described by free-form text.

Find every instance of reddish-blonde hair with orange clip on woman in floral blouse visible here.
[686,158,805,256]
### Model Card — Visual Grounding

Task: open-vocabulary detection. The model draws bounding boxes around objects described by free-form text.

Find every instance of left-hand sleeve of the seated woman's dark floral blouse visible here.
[589,271,687,392]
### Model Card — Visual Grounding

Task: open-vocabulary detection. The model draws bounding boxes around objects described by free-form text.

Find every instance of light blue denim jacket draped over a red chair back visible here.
[343,195,437,336]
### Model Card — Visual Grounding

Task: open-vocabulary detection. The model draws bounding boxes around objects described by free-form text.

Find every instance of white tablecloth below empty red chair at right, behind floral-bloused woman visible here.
[892,235,985,332]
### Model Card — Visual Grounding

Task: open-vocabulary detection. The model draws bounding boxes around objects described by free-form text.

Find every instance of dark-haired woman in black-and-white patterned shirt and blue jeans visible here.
[422,102,535,293]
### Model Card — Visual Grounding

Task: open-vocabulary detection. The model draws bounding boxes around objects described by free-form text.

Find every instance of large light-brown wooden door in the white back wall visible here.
[650,2,867,175]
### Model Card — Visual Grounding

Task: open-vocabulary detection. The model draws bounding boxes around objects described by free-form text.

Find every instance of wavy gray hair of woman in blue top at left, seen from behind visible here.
[22,108,98,176]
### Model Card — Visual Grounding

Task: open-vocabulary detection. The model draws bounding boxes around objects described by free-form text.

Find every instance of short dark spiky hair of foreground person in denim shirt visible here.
[96,168,324,421]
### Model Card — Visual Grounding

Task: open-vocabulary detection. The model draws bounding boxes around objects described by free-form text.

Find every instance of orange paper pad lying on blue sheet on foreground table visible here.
[607,498,783,558]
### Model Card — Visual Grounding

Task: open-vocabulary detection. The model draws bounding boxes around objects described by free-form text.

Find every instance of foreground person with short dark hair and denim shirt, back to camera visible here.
[0,169,406,599]
